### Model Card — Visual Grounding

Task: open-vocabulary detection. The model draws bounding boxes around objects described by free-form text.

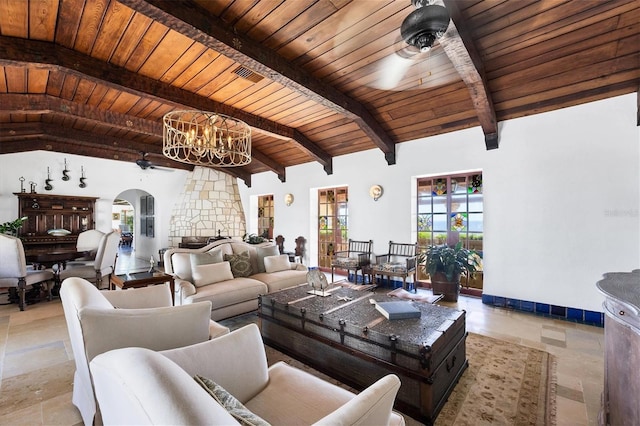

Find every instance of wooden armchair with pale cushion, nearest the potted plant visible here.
[371,241,418,291]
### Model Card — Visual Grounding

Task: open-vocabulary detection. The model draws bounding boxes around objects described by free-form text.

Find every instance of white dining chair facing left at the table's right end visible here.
[57,232,120,289]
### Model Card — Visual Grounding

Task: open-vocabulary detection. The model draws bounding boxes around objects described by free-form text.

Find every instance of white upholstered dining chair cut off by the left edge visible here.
[0,234,54,311]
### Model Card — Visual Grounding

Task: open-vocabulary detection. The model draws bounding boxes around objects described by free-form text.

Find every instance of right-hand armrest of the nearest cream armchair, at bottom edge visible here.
[315,374,400,426]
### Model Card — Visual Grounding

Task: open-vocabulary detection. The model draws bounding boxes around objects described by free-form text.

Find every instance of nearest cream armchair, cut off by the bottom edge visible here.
[91,324,404,425]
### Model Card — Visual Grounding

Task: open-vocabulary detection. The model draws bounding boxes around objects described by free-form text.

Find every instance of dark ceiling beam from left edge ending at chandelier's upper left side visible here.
[0,93,162,138]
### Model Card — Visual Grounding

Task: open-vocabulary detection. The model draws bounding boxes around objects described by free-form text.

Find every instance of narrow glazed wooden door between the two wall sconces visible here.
[318,187,349,268]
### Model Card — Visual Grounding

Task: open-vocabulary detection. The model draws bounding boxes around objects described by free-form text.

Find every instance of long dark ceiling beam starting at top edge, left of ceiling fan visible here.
[119,0,396,165]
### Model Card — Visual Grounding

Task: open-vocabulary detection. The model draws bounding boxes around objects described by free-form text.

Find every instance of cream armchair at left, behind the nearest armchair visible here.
[60,277,229,425]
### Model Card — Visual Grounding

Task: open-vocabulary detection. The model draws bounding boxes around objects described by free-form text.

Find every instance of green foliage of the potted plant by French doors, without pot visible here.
[419,243,482,282]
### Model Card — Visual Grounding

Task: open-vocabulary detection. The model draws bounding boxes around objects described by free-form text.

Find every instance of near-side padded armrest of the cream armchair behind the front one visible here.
[78,300,211,362]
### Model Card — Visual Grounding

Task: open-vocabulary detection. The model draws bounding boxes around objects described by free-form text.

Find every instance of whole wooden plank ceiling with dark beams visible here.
[0,0,640,185]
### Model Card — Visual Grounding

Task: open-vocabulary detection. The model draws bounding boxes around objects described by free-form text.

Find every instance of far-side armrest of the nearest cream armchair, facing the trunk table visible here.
[162,324,269,403]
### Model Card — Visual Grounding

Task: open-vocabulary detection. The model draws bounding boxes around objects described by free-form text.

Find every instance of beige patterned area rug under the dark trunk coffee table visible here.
[225,314,556,426]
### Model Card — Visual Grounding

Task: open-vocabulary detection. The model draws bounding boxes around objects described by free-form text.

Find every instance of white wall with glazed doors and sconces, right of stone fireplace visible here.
[238,94,640,311]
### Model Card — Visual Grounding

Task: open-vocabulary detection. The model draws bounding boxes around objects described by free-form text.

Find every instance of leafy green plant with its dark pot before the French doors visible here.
[420,242,482,302]
